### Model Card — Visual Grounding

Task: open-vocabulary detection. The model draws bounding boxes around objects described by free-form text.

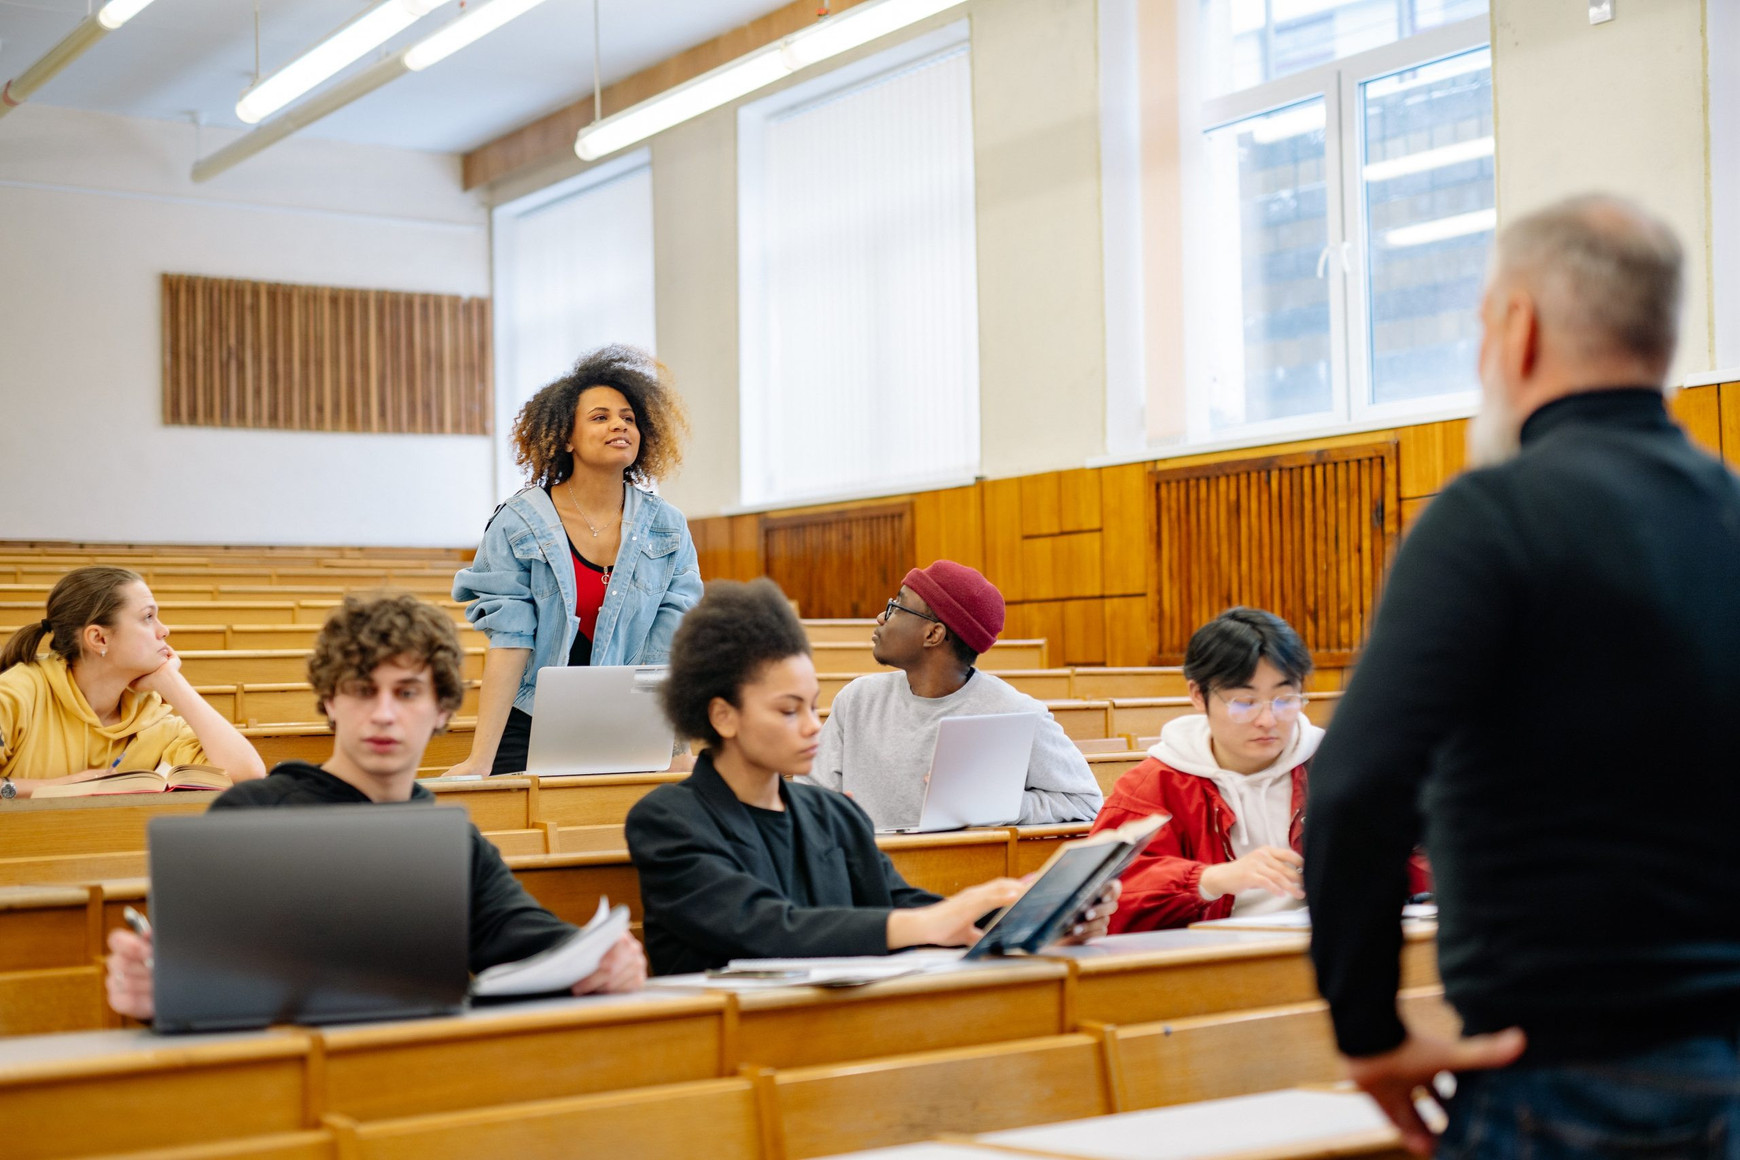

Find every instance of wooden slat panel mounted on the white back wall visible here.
[164,275,494,435]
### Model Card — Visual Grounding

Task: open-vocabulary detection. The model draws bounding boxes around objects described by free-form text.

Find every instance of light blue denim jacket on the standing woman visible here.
[452,485,701,713]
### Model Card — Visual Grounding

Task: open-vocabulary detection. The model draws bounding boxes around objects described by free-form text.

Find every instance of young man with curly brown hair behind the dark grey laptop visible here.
[108,595,646,1019]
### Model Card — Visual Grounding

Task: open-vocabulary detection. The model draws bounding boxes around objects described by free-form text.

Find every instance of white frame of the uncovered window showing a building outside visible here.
[1176,17,1491,456]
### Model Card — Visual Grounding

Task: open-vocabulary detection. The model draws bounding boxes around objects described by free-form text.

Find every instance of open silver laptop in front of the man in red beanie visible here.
[882,713,1039,833]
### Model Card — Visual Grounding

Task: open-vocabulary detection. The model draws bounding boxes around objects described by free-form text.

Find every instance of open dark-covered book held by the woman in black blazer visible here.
[966,814,1171,958]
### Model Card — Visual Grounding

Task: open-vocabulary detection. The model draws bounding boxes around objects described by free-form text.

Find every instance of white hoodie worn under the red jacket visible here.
[1148,713,1322,917]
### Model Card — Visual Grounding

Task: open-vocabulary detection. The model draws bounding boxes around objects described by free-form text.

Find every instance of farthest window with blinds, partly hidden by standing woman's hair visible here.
[494,150,656,494]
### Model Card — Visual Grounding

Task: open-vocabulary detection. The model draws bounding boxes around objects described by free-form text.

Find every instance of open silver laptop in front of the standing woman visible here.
[525,664,677,777]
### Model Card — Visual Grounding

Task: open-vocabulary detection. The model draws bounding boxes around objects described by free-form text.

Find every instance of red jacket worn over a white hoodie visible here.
[1089,757,1432,934]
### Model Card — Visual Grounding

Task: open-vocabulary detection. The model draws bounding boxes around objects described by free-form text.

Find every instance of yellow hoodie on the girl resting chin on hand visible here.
[0,652,205,777]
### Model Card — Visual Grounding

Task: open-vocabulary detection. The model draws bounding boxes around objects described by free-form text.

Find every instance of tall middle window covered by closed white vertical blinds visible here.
[738,24,980,504]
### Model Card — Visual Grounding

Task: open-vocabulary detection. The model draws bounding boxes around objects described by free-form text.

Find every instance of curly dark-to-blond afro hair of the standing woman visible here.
[513,346,689,487]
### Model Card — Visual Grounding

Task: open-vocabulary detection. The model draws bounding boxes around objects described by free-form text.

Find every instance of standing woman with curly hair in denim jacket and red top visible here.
[447,346,701,776]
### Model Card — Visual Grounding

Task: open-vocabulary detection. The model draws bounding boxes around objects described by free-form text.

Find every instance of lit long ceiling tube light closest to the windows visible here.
[581,0,966,162]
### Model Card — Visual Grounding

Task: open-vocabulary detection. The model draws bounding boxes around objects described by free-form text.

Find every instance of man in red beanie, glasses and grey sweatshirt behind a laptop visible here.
[806,560,1100,830]
